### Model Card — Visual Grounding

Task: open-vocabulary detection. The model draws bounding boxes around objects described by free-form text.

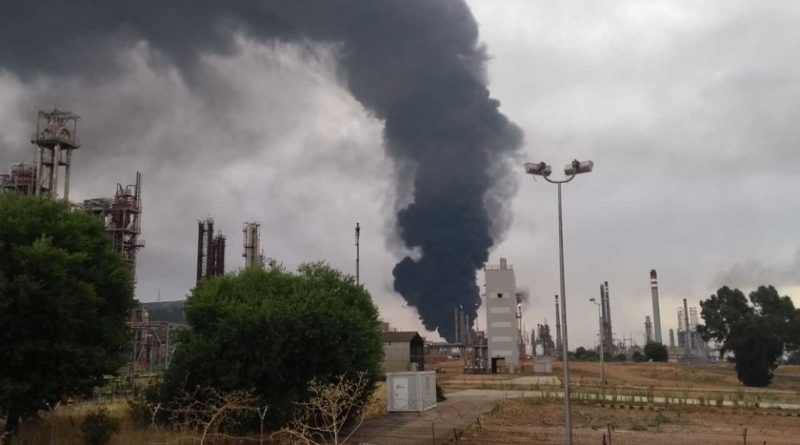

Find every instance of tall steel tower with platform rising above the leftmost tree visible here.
[31,108,80,200]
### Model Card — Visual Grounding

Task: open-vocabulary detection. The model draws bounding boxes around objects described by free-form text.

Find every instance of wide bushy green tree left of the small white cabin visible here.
[162,263,383,427]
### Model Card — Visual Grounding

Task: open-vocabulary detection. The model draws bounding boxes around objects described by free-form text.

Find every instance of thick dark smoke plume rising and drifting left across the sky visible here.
[0,0,522,339]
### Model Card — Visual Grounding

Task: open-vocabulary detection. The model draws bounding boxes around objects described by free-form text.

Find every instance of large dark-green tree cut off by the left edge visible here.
[0,194,134,432]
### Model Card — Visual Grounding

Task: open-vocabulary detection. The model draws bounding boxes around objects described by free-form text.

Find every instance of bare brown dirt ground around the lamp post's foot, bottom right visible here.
[458,399,800,445]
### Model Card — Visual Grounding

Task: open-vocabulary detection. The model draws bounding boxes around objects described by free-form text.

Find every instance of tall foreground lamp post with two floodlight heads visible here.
[525,159,594,445]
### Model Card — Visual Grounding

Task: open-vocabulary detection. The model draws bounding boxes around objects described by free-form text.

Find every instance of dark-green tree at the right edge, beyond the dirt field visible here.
[698,286,800,386]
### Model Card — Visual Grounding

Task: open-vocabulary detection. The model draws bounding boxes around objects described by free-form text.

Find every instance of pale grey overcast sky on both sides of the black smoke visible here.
[0,0,800,348]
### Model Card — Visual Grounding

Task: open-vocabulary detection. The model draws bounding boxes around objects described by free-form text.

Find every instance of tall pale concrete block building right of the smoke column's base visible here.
[484,258,520,373]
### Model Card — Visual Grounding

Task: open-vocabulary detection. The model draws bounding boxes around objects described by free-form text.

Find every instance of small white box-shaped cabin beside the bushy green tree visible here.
[386,371,436,412]
